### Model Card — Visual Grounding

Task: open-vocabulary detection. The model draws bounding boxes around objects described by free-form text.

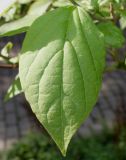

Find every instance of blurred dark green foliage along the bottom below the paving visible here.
[1,129,126,160]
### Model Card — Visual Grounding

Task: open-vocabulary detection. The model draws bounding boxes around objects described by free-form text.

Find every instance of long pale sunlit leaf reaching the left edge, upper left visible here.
[0,0,51,37]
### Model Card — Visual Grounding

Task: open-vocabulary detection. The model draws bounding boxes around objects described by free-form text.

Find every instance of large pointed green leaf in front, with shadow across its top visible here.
[19,7,105,155]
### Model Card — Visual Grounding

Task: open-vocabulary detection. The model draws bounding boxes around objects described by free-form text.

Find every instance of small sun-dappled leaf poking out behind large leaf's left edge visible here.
[4,75,22,101]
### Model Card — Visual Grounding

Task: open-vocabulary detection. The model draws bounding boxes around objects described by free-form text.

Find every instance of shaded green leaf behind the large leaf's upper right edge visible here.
[98,22,125,48]
